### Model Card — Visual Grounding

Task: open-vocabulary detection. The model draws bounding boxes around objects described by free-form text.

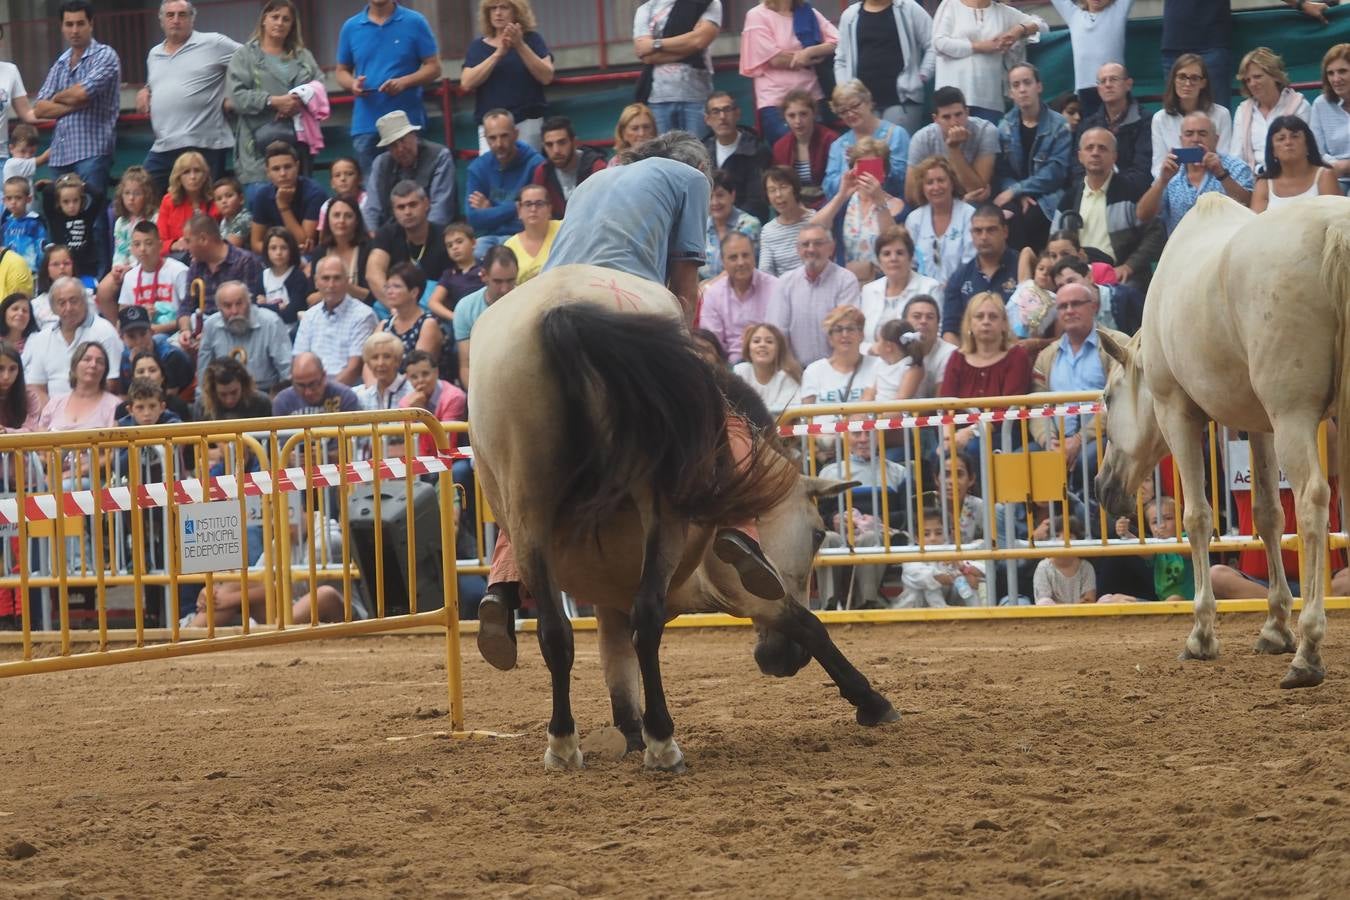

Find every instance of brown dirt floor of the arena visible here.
[0,613,1350,900]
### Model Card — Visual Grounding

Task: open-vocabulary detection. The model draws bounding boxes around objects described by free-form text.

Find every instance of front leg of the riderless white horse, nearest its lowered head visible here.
[1154,401,1219,660]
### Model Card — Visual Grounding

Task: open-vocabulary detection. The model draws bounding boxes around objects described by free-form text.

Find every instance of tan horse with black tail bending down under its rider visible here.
[468,266,899,770]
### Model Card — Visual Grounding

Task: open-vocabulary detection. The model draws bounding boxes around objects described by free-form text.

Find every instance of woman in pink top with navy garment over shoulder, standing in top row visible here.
[741,0,840,146]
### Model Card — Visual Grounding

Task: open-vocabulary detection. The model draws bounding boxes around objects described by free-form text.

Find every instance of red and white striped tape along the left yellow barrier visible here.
[0,447,473,525]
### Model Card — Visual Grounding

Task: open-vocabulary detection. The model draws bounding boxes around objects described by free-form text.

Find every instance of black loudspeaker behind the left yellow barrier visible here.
[348,482,446,615]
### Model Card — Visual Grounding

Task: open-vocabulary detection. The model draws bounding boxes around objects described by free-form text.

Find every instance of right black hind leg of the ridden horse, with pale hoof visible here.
[633,511,684,772]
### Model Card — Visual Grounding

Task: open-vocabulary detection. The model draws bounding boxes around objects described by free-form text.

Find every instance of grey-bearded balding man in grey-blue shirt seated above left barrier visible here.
[197,281,292,395]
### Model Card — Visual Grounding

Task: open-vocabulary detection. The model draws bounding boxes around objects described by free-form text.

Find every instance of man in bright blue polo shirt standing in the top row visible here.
[336,0,440,173]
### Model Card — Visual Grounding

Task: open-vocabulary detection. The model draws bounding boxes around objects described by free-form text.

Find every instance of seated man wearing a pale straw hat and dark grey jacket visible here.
[360,109,456,232]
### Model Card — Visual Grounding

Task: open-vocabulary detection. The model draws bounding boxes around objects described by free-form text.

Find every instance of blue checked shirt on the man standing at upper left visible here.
[38,40,122,166]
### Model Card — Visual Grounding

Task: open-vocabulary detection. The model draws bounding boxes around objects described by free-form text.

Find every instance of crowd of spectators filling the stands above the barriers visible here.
[0,0,1350,626]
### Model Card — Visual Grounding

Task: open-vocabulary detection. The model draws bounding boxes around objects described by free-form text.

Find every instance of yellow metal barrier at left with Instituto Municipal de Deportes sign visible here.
[0,410,464,731]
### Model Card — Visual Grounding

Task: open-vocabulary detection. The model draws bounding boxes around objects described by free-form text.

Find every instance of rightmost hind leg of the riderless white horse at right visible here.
[1274,417,1331,688]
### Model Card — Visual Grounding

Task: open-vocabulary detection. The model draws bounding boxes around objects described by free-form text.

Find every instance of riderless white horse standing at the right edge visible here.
[1098,193,1350,688]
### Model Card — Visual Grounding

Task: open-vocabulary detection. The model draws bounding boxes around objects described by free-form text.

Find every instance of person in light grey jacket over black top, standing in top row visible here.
[834,0,936,135]
